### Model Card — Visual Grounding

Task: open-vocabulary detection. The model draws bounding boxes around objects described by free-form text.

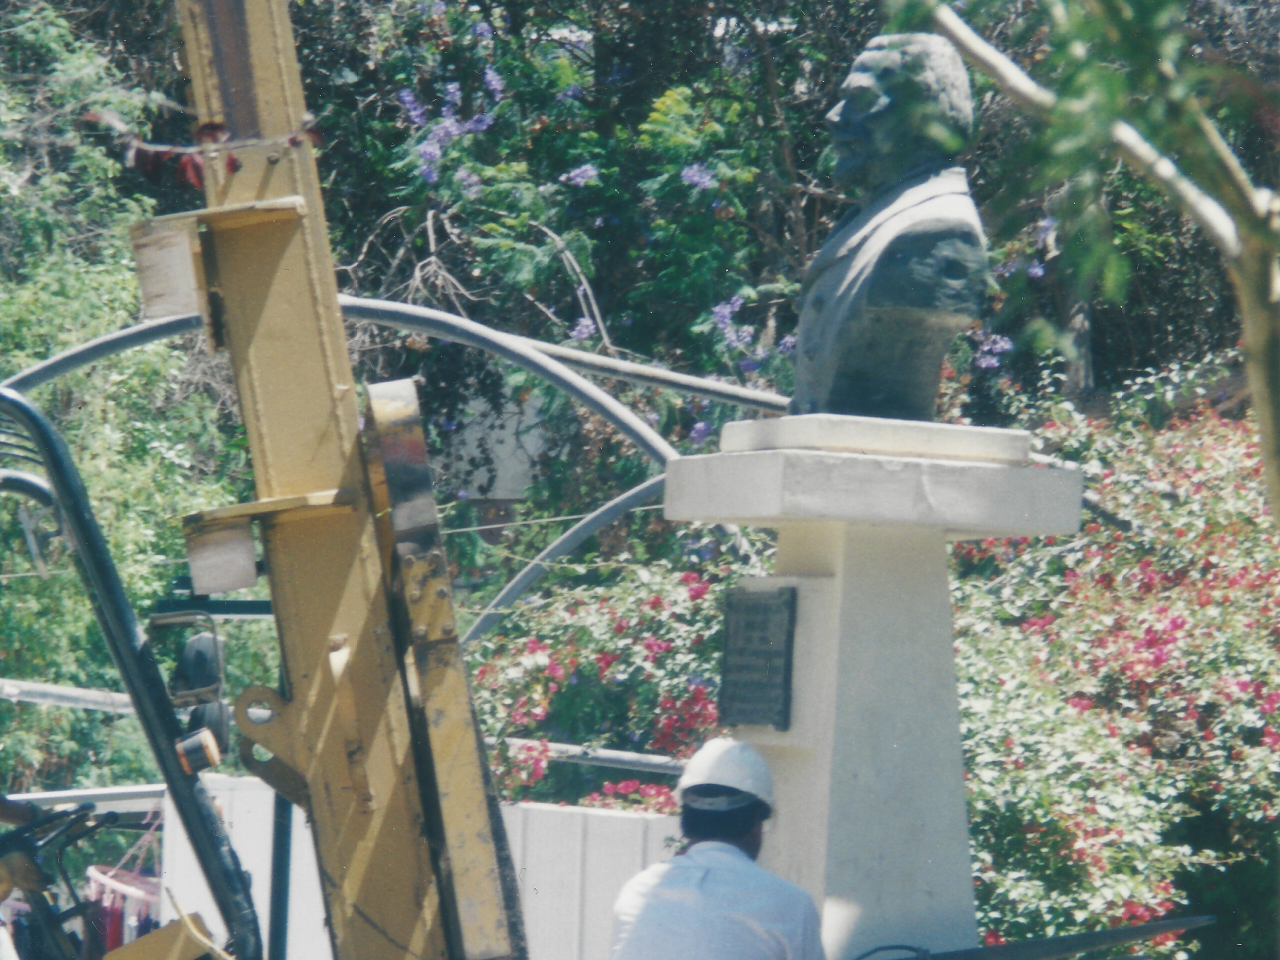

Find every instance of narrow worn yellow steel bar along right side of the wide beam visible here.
[366,380,512,960]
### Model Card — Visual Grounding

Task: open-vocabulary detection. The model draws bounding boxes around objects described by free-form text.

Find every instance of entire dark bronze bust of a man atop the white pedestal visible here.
[791,33,987,420]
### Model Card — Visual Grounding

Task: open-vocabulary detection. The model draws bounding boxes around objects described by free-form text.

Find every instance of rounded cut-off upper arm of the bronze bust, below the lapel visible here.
[867,220,987,317]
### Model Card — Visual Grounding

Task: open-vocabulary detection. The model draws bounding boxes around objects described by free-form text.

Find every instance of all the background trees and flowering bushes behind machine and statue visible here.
[0,0,1280,960]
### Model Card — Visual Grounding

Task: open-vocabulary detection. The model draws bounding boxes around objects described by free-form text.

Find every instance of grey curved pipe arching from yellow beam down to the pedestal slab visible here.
[338,296,680,463]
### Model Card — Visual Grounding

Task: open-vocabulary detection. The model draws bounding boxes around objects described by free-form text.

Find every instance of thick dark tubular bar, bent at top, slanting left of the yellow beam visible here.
[0,387,262,960]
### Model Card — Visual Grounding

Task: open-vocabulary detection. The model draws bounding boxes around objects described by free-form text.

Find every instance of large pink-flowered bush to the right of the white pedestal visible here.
[952,350,1280,956]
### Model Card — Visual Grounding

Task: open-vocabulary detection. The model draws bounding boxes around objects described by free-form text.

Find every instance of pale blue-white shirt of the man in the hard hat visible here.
[612,841,826,960]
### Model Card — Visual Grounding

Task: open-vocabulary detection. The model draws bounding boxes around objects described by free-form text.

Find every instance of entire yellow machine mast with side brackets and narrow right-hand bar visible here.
[127,0,524,960]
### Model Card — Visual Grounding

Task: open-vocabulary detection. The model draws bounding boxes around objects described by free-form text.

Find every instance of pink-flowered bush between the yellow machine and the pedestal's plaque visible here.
[471,563,730,809]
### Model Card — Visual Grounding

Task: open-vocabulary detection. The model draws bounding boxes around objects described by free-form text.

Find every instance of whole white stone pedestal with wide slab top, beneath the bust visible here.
[666,415,1083,960]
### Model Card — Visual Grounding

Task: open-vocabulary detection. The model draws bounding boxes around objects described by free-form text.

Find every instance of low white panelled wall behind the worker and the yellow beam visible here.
[161,773,680,960]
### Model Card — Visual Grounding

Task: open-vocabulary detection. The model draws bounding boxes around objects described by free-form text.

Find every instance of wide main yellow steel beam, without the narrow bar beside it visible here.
[170,0,445,960]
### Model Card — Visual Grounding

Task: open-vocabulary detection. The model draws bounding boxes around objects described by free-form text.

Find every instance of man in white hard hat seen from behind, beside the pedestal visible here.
[612,737,824,960]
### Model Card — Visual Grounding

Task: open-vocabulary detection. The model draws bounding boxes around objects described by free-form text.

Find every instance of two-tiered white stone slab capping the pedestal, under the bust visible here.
[666,415,1083,540]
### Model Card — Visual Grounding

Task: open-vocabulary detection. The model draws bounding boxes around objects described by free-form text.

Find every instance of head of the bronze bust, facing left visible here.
[827,33,973,189]
